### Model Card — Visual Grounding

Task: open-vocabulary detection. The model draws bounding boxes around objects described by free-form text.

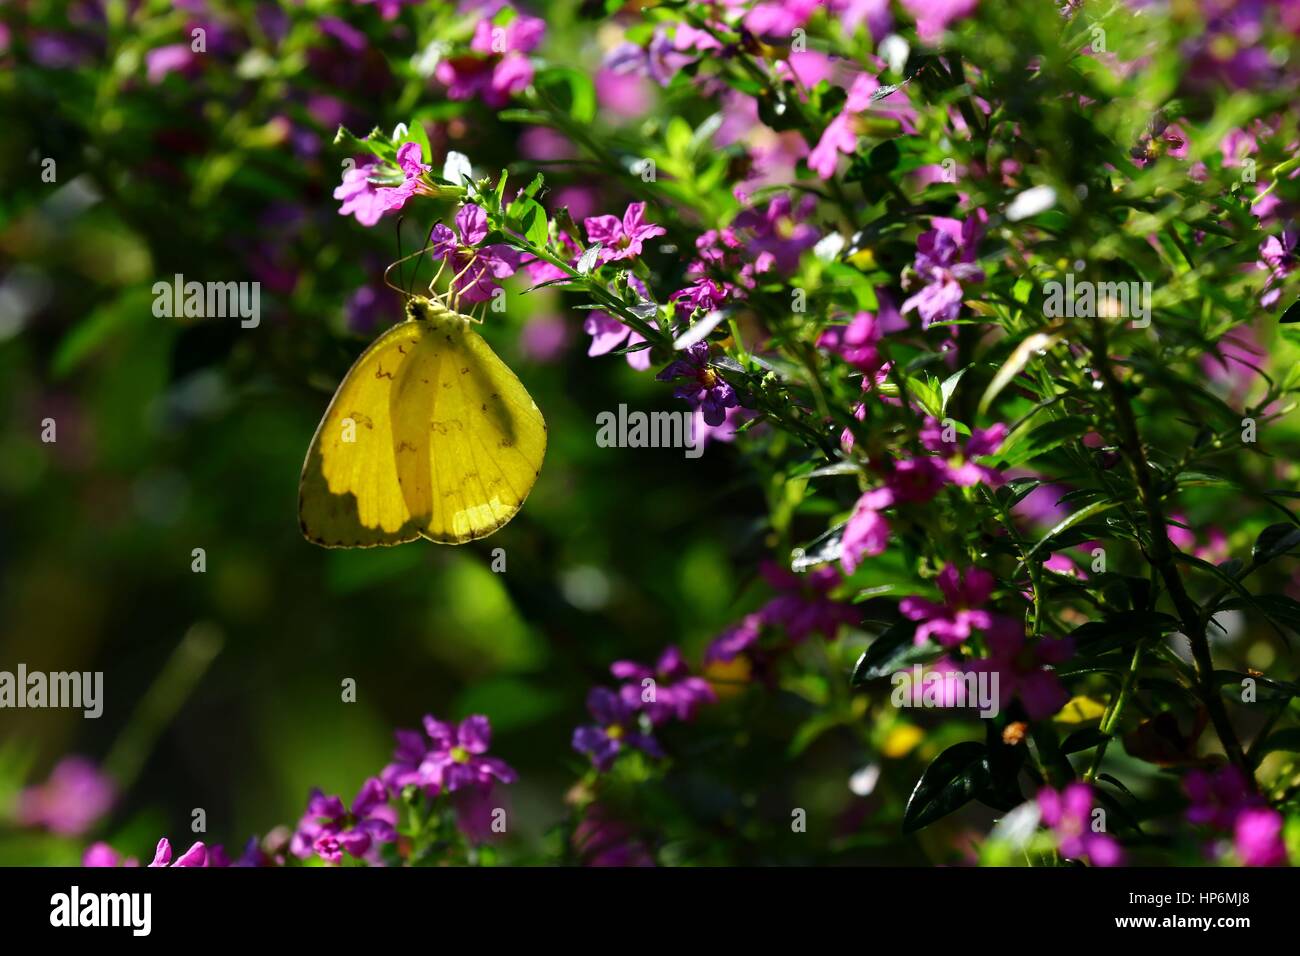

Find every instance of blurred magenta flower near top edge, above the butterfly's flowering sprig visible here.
[434,17,546,109]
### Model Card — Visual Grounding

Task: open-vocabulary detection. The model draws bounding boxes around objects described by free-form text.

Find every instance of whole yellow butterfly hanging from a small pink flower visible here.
[298,295,546,548]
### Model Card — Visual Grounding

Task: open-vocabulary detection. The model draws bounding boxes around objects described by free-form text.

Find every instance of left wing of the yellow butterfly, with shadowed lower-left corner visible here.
[298,321,428,548]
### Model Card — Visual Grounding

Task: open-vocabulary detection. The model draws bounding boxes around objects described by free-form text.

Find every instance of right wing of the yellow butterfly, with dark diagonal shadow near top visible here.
[399,323,546,544]
